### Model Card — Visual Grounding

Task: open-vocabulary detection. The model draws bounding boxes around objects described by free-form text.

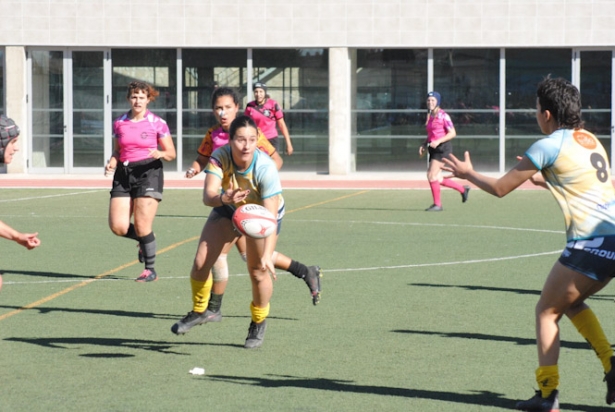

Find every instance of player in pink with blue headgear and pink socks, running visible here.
[419,91,470,212]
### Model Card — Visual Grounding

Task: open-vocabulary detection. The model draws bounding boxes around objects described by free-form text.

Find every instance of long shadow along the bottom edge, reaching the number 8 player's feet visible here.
[203,375,605,412]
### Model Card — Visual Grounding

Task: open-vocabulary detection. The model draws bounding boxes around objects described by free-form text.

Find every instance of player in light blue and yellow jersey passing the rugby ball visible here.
[171,115,284,349]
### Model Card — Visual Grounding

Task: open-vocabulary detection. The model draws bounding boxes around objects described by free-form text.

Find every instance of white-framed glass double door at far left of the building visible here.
[28,49,111,174]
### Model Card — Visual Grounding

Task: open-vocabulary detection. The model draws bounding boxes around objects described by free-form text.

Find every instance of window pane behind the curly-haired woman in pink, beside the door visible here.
[111,49,177,170]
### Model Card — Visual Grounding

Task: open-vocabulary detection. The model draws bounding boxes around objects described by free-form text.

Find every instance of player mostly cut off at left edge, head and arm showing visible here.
[0,115,41,289]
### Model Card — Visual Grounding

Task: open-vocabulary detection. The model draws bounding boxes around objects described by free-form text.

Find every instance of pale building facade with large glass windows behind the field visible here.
[0,0,615,175]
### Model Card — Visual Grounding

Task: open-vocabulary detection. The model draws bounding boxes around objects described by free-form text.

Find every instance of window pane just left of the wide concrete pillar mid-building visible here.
[252,49,329,172]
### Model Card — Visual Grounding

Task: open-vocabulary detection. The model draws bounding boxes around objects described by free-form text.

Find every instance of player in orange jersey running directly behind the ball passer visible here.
[179,87,321,333]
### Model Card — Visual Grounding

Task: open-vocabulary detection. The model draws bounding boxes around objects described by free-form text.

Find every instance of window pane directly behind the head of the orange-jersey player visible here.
[182,49,247,170]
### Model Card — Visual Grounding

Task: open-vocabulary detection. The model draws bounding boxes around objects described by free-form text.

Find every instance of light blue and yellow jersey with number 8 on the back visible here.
[525,129,615,241]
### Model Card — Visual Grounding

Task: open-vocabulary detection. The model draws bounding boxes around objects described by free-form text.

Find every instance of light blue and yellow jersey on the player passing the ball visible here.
[205,145,284,219]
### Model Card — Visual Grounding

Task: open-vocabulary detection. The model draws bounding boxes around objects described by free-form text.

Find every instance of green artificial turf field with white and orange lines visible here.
[0,189,615,412]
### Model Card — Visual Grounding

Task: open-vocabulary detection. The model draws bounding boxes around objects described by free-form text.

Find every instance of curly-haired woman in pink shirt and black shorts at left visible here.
[105,81,176,282]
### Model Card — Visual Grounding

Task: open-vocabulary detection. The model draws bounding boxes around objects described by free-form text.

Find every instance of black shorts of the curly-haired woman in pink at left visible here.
[110,159,164,200]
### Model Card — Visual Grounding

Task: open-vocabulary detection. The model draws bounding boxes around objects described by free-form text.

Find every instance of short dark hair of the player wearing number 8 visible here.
[536,76,583,129]
